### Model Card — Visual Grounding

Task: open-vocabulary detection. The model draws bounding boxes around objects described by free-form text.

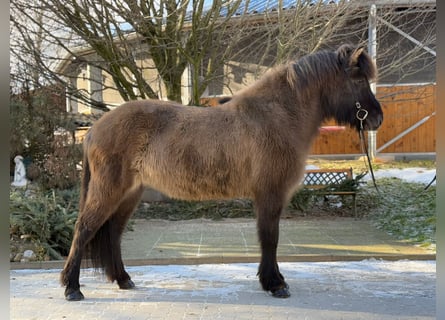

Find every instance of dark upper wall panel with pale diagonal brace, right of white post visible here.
[377,1,436,84]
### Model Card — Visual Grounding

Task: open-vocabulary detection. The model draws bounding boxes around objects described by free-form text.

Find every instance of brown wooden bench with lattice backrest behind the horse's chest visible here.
[303,168,357,218]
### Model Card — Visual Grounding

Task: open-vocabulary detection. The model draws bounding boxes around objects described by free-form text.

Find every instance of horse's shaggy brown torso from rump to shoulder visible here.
[82,98,306,200]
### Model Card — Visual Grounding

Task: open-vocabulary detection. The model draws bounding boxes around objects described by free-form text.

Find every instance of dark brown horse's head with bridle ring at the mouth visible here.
[336,45,383,130]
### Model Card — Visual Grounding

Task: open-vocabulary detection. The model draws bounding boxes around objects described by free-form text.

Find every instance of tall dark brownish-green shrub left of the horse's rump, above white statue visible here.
[9,87,82,190]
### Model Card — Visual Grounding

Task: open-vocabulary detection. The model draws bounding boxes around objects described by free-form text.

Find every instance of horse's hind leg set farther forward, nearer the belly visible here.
[100,187,143,289]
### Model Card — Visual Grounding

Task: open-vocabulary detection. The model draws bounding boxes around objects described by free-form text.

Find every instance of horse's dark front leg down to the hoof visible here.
[256,199,290,298]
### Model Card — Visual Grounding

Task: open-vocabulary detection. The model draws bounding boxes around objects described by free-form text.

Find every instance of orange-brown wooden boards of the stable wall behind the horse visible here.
[202,84,436,155]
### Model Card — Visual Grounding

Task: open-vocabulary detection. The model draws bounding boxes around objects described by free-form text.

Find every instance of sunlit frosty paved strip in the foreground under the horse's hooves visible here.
[10,259,436,320]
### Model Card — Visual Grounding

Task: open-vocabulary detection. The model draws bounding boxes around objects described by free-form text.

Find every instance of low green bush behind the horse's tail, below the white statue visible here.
[9,188,79,260]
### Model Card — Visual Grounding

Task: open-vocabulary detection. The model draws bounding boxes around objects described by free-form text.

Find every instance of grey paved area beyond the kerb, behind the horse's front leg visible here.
[122,218,434,263]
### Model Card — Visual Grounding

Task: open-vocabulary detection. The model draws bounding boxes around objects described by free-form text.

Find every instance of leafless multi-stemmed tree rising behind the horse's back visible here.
[12,0,251,101]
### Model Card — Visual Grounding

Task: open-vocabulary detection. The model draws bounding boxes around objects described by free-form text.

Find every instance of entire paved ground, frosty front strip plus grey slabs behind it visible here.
[10,218,436,320]
